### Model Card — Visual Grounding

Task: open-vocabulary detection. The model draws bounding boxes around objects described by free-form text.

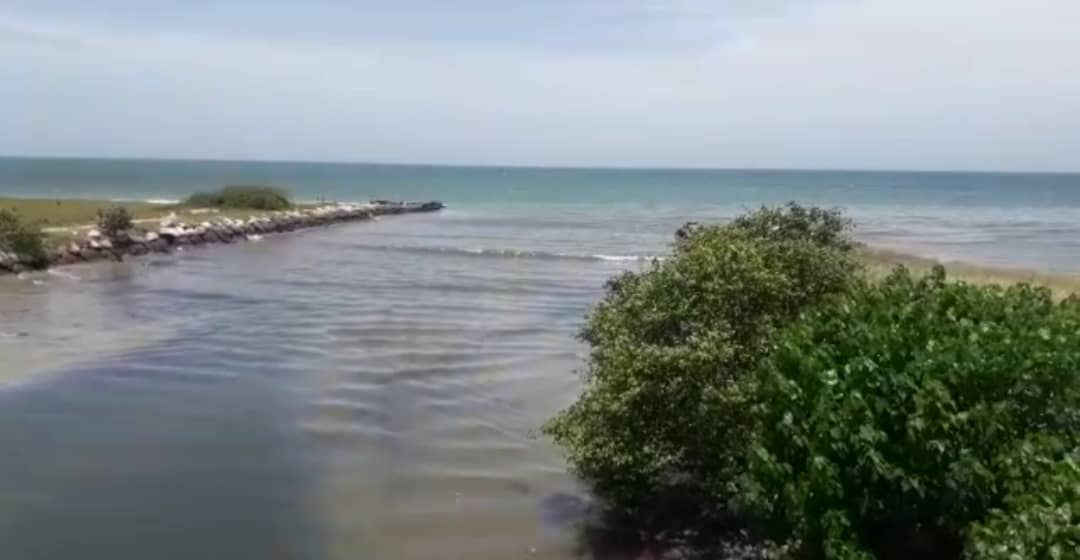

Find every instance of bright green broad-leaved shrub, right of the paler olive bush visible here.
[741,268,1080,559]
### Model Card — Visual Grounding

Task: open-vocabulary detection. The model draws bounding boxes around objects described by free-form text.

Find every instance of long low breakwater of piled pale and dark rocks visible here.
[0,201,444,273]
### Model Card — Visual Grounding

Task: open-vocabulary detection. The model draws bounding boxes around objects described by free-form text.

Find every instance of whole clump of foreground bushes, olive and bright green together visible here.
[544,205,1080,560]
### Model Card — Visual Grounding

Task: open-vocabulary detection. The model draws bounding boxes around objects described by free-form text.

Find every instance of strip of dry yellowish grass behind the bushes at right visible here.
[860,247,1080,298]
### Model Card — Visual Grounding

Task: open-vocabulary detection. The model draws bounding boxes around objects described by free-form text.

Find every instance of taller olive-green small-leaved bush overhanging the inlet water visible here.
[544,204,859,514]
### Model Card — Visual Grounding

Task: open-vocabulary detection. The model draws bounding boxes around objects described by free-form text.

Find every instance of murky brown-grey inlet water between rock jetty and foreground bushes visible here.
[0,215,626,560]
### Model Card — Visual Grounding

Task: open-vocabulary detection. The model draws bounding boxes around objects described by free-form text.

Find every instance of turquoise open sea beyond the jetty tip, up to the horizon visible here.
[6,154,1080,271]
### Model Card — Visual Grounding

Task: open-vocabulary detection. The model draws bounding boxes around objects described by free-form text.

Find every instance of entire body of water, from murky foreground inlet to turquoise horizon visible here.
[0,159,1080,560]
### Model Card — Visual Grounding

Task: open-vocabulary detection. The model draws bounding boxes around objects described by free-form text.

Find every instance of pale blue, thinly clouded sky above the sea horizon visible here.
[0,0,1080,170]
